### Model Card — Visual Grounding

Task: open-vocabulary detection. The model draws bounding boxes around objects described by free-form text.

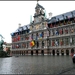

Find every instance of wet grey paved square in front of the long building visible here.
[0,56,75,75]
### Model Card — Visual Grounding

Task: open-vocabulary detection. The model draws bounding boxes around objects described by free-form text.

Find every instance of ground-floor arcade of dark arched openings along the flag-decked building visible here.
[11,48,75,55]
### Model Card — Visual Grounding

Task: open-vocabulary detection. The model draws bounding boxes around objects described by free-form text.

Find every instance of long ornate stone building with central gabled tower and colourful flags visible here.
[11,3,75,55]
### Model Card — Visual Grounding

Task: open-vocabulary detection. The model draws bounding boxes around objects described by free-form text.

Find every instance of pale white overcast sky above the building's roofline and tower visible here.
[0,1,75,43]
